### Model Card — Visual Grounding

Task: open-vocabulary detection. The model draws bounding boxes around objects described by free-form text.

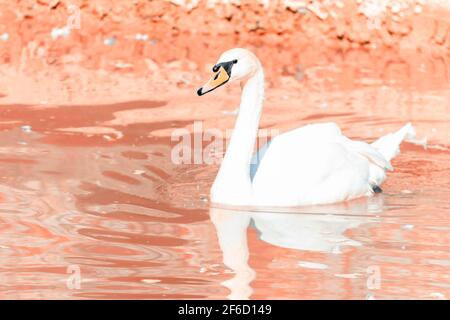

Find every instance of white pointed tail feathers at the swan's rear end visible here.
[372,122,416,161]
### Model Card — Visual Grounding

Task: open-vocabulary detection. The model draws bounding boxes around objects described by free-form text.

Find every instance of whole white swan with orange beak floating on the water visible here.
[197,48,414,207]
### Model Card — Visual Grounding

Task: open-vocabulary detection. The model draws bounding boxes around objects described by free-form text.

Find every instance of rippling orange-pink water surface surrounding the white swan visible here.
[0,48,450,299]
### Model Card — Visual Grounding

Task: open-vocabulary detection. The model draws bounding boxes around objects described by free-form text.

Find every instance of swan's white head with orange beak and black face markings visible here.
[197,48,260,96]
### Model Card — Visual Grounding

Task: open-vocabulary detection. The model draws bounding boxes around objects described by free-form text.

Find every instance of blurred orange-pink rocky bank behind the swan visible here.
[0,0,450,104]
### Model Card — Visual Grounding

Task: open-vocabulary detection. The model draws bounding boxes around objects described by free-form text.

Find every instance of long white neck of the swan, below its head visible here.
[212,67,264,203]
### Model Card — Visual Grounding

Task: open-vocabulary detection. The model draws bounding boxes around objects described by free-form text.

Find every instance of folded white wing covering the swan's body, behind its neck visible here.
[253,123,390,205]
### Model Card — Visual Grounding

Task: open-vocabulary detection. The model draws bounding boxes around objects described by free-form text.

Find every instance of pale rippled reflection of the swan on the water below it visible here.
[210,195,384,299]
